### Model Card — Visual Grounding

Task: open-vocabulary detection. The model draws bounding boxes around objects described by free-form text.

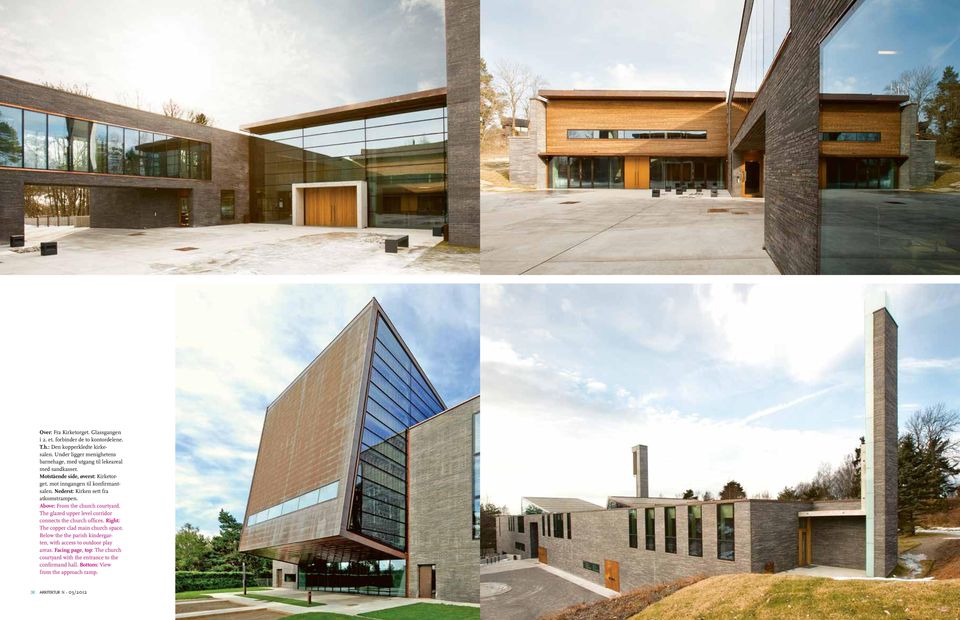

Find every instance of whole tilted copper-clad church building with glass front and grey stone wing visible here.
[240,299,480,601]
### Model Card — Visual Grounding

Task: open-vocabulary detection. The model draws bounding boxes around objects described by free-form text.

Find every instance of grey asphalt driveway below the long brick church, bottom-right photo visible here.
[480,567,604,620]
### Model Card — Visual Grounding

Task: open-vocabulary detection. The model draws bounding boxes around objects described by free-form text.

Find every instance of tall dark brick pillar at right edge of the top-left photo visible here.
[446,0,480,247]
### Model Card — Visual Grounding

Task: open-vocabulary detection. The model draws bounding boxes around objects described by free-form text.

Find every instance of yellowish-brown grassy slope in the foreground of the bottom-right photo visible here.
[634,574,960,620]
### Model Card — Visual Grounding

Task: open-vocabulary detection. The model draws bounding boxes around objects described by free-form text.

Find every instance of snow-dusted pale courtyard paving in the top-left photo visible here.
[0,224,480,275]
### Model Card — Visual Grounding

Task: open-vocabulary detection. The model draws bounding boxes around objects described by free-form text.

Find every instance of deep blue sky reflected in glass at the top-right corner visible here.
[823,0,960,93]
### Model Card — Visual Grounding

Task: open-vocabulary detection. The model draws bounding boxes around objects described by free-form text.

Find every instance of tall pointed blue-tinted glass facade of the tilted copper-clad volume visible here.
[349,316,443,551]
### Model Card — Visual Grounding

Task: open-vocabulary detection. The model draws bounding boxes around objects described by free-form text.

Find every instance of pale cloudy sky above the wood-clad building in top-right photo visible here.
[480,0,743,91]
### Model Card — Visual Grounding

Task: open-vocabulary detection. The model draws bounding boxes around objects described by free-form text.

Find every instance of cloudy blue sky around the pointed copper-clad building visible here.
[176,283,480,534]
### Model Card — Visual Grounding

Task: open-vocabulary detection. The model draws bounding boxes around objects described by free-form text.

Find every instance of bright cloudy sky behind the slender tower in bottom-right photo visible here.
[481,281,960,509]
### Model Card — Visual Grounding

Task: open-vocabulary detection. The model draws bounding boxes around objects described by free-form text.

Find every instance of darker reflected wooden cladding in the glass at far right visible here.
[820,102,900,157]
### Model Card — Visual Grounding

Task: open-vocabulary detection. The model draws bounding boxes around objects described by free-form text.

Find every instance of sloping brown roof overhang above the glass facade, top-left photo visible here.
[240,87,447,135]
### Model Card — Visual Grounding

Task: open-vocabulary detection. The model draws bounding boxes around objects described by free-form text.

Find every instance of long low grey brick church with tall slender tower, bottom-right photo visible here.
[497,304,898,591]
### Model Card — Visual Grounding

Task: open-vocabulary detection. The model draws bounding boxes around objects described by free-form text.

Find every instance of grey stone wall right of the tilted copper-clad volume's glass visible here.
[407,396,480,603]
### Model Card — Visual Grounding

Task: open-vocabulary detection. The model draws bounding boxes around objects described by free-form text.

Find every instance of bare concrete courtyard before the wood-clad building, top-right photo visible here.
[480,190,778,275]
